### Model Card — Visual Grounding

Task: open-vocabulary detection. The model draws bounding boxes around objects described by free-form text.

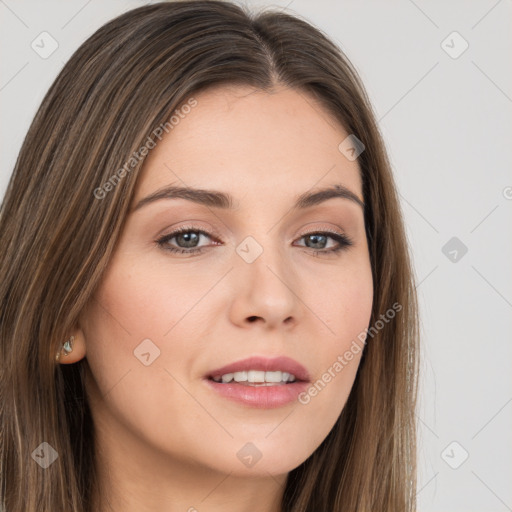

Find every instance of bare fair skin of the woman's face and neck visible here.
[64,86,373,512]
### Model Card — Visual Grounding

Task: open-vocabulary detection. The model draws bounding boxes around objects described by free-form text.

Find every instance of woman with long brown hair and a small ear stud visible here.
[0,0,418,512]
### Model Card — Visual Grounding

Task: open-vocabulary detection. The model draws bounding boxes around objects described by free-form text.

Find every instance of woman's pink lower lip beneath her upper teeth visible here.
[205,379,309,409]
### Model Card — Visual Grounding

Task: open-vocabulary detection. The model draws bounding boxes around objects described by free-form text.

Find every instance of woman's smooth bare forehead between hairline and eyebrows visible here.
[134,86,362,207]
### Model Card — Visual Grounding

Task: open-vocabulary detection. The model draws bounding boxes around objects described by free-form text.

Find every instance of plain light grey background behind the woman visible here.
[0,0,512,512]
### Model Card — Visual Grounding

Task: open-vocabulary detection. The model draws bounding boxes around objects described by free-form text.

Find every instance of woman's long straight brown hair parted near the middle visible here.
[0,0,419,512]
